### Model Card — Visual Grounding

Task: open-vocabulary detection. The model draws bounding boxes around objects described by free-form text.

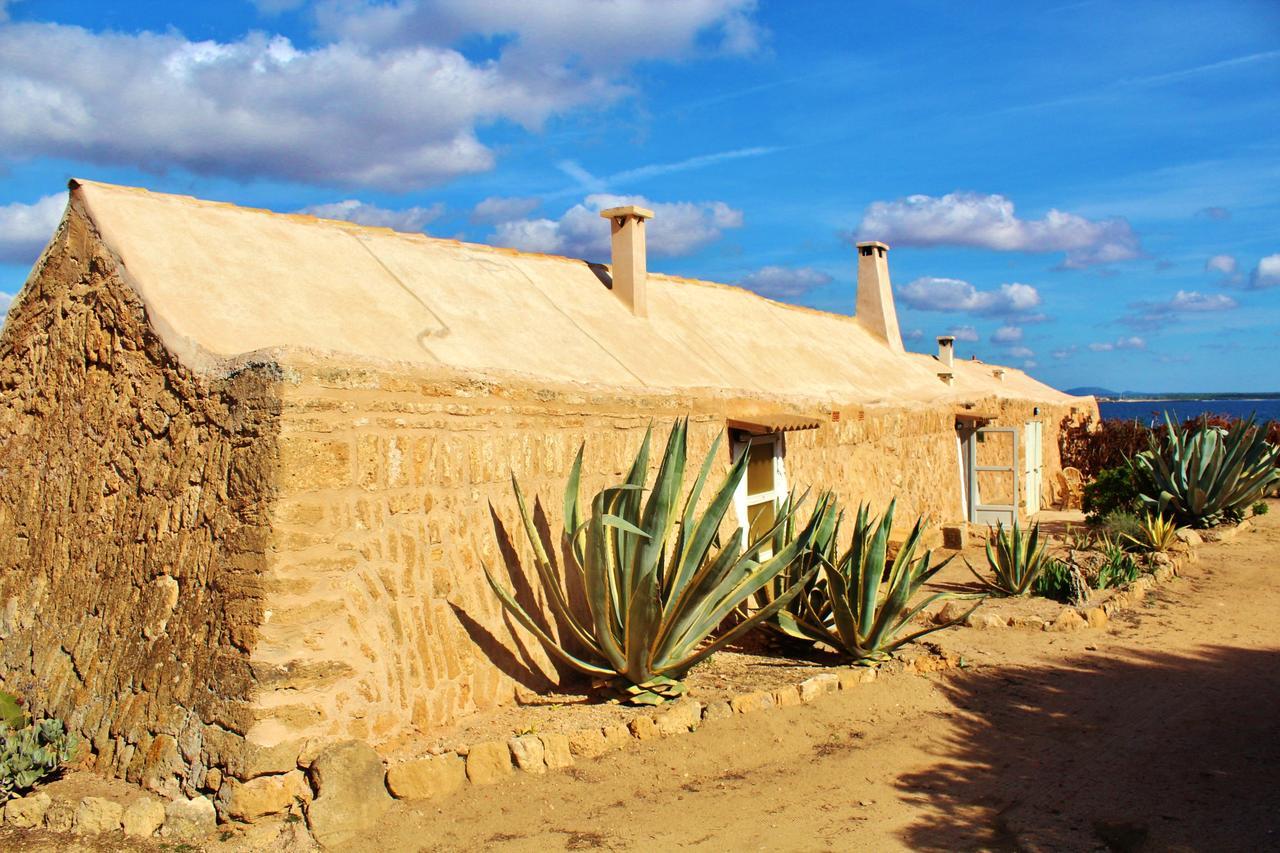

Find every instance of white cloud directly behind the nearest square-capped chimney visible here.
[494,193,742,260]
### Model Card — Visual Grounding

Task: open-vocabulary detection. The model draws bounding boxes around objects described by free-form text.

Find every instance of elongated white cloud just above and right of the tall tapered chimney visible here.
[858,192,1143,269]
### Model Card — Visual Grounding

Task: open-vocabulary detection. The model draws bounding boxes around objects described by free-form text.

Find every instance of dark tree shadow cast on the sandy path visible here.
[897,647,1280,850]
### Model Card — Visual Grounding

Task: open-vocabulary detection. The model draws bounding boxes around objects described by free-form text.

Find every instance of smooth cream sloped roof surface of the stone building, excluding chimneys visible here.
[62,181,1071,402]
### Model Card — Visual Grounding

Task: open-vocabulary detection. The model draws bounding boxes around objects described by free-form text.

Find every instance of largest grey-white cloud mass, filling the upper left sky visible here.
[0,0,753,190]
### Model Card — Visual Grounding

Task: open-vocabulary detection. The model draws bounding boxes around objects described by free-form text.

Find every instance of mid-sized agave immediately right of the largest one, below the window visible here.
[752,497,984,662]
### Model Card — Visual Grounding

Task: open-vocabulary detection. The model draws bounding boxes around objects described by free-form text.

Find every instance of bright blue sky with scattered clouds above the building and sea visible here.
[0,0,1280,391]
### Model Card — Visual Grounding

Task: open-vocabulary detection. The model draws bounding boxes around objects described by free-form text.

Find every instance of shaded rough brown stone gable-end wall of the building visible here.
[0,210,279,793]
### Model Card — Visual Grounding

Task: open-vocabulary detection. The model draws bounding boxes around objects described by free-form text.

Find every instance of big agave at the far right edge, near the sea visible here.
[1133,412,1280,528]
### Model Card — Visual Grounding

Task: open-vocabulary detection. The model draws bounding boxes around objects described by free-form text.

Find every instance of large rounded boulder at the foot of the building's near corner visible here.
[307,740,393,848]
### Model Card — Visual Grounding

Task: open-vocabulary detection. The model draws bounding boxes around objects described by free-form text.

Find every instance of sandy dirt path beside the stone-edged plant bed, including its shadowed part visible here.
[350,502,1280,852]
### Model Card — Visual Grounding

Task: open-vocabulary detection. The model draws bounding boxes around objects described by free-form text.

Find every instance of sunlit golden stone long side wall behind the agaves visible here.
[259,361,1090,744]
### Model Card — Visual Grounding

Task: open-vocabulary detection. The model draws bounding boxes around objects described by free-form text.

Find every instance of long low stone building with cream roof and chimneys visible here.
[0,181,1094,794]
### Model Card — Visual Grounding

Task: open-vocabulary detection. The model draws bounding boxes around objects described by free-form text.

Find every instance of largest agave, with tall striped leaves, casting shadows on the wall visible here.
[485,420,814,703]
